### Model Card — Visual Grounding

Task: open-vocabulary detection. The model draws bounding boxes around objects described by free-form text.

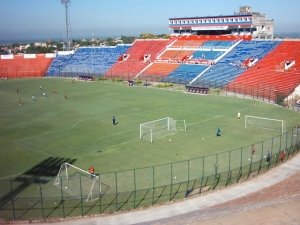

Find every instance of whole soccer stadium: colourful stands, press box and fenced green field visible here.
[0,4,300,224]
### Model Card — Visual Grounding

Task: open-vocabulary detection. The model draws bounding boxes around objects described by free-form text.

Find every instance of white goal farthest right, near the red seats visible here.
[245,115,287,134]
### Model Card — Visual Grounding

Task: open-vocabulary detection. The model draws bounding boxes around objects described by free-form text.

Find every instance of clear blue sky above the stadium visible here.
[0,0,300,43]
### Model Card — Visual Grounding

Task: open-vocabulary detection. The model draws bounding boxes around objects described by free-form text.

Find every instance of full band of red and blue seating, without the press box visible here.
[0,36,300,103]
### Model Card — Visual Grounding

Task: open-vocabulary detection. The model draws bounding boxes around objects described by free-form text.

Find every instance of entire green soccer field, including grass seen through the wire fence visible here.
[0,78,300,220]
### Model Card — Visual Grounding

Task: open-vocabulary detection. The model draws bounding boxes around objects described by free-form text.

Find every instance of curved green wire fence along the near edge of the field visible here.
[0,128,300,221]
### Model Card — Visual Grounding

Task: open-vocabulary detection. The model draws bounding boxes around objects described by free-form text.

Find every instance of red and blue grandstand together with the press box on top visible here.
[0,6,300,101]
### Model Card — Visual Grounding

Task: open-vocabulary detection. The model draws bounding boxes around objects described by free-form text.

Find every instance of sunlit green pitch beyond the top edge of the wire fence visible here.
[0,78,300,187]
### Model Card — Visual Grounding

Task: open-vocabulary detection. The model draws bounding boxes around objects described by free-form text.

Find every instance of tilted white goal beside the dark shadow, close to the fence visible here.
[54,163,101,202]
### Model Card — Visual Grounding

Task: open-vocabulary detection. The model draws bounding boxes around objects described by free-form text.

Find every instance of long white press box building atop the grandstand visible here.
[169,6,274,39]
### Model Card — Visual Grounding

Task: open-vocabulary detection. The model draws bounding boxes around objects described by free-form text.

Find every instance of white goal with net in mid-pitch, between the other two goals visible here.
[140,117,186,143]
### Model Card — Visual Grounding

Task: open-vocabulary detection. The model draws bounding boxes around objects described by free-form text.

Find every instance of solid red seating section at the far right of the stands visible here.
[227,41,300,100]
